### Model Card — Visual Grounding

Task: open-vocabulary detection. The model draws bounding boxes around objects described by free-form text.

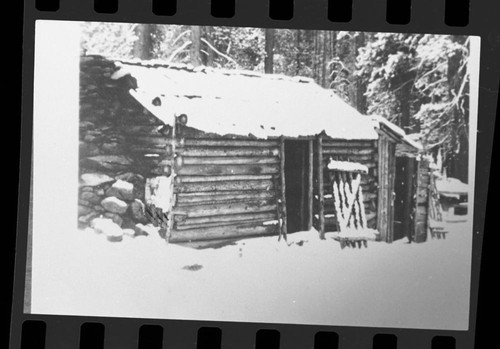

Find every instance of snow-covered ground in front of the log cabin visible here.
[32,218,472,330]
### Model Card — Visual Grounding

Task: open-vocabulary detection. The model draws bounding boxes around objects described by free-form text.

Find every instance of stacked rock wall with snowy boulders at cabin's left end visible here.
[78,56,165,241]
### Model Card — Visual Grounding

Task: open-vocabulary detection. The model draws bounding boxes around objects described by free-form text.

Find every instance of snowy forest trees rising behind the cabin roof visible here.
[81,22,470,183]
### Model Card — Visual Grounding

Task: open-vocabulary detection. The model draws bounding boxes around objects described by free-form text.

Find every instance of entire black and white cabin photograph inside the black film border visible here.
[24,20,480,330]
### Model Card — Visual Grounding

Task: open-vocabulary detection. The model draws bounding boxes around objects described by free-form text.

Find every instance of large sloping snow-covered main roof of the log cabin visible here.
[114,61,378,139]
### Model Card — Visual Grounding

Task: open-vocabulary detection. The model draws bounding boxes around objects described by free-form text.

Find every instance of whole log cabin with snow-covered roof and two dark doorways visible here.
[80,56,429,243]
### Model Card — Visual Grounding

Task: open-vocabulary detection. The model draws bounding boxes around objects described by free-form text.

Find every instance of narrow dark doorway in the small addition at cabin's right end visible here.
[393,157,416,241]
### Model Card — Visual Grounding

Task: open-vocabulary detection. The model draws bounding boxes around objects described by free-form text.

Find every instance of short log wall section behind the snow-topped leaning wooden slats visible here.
[314,138,378,232]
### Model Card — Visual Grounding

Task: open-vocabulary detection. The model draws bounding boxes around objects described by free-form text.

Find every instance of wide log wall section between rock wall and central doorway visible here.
[169,138,282,242]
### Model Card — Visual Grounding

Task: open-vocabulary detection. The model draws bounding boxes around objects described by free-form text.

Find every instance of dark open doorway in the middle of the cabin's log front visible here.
[285,140,312,233]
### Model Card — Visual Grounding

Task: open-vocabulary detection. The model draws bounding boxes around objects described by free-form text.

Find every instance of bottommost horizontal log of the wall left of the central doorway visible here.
[169,223,278,243]
